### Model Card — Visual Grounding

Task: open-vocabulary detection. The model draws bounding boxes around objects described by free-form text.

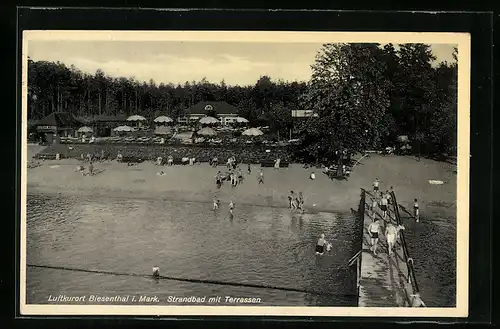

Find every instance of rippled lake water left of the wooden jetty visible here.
[26,194,360,306]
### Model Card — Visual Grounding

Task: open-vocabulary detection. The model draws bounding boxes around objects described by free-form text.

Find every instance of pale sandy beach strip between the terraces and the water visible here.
[27,146,456,217]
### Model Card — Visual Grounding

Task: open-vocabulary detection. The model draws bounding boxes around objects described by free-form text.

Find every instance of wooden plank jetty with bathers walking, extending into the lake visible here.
[358,191,411,307]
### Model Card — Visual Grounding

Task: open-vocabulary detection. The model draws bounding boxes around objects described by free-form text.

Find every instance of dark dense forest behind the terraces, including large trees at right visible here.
[28,44,457,154]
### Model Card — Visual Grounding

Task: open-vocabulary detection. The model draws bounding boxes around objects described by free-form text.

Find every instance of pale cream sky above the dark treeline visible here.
[28,40,455,85]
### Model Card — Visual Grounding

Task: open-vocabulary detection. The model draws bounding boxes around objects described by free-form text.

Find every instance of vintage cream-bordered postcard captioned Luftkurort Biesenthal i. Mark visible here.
[19,30,470,317]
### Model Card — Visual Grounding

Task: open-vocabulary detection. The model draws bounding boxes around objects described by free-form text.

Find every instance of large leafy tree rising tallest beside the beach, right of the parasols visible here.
[300,44,390,167]
